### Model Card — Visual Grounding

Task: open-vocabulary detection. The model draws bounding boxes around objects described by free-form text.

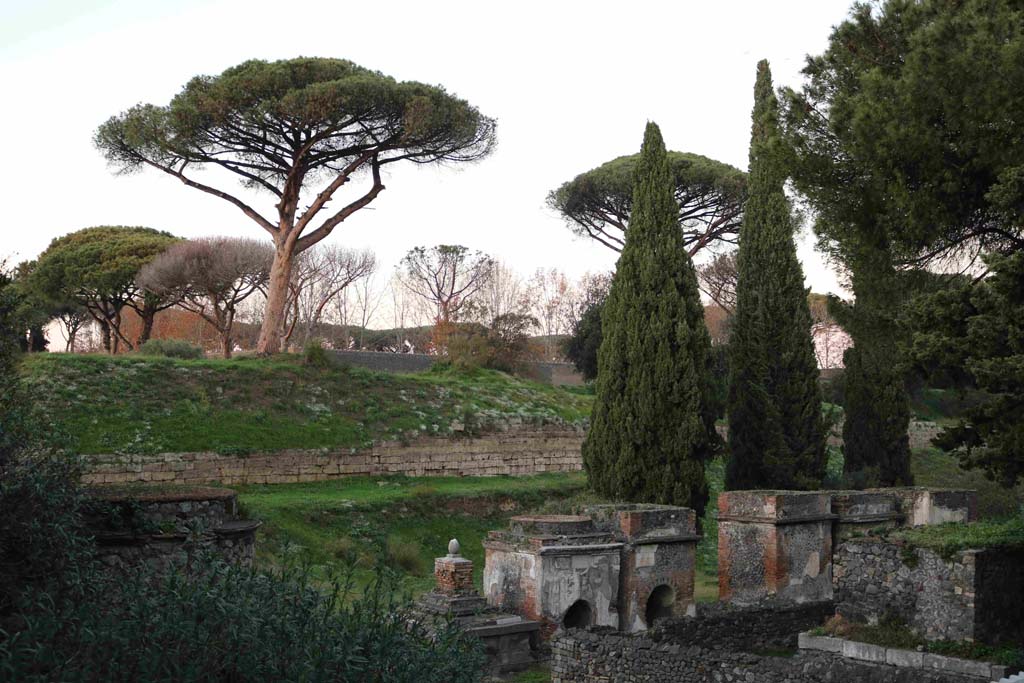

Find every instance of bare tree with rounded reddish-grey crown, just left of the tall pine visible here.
[138,238,273,358]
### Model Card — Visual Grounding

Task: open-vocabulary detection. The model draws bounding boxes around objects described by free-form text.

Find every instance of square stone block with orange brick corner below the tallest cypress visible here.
[718,490,836,603]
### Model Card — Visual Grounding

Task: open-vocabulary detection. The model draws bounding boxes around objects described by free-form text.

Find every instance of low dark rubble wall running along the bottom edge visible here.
[551,631,992,683]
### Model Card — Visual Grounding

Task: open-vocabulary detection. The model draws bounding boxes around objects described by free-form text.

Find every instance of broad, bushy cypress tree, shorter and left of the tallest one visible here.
[583,123,720,515]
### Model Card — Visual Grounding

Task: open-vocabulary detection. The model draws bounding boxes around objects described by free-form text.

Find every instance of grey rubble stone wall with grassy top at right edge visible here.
[833,538,1024,642]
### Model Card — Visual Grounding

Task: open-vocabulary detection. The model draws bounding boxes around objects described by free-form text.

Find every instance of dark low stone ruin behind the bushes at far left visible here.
[86,487,260,571]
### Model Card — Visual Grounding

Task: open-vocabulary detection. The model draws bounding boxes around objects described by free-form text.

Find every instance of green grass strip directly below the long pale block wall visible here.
[238,473,586,594]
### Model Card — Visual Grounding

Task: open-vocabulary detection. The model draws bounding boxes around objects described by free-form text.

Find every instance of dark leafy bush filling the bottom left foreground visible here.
[0,562,484,683]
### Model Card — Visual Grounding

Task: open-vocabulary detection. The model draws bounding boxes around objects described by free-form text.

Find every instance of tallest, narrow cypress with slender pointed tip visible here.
[726,60,826,488]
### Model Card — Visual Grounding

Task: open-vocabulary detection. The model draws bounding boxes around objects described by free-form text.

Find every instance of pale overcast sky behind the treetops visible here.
[0,0,851,292]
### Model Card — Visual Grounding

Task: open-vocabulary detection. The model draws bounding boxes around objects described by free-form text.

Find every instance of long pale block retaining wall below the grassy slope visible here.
[83,425,585,484]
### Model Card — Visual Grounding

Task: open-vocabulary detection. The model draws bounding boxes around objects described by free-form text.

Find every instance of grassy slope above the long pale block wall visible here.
[22,353,593,455]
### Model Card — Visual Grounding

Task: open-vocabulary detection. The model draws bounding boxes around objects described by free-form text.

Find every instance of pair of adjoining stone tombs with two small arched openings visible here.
[483,505,699,636]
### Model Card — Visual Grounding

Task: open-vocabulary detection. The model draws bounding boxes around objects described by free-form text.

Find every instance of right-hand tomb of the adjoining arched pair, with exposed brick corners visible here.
[587,504,700,632]
